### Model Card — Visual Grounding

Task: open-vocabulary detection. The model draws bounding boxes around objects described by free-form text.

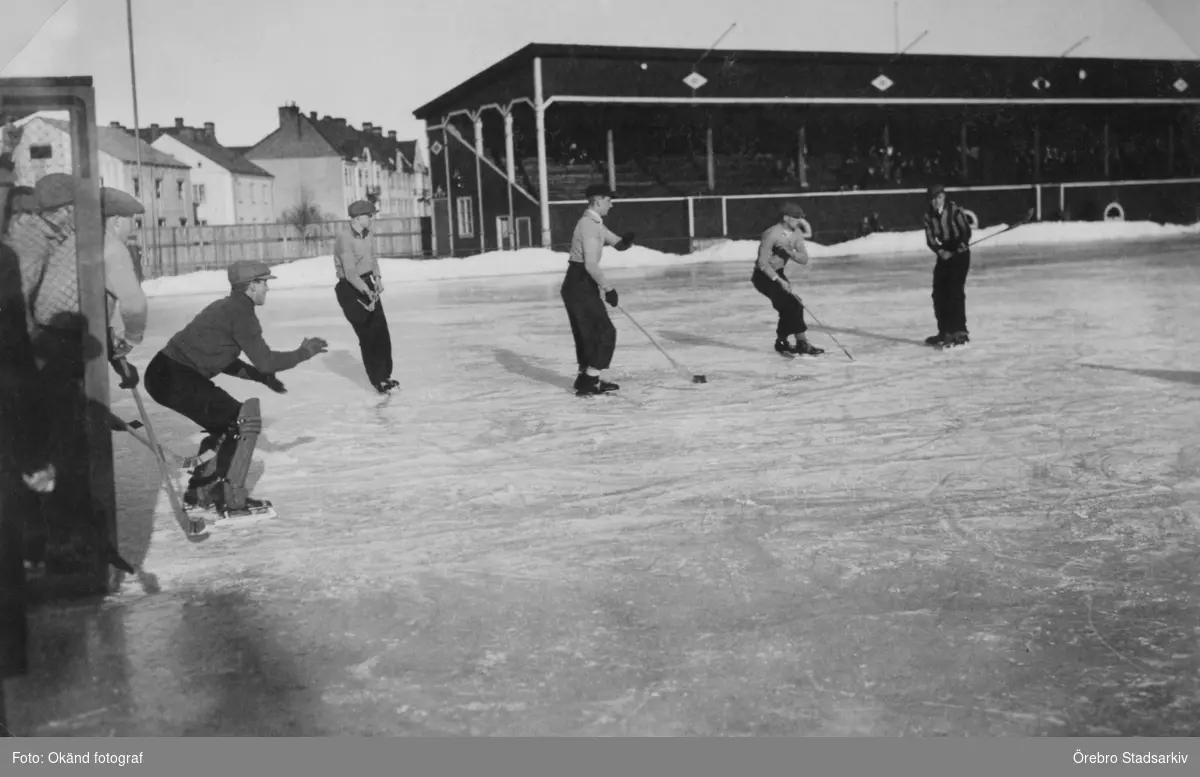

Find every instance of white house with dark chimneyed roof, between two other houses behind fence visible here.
[146,119,276,225]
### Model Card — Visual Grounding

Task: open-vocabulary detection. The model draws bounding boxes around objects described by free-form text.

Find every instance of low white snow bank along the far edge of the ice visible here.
[142,222,1200,303]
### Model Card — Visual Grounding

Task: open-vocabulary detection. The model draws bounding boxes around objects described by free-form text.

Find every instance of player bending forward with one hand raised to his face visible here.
[750,201,824,356]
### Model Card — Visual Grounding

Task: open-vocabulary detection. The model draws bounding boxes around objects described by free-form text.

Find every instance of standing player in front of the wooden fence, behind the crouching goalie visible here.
[334,200,400,393]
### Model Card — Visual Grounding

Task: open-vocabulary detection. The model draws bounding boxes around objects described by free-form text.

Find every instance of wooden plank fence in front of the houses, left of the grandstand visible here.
[134,217,433,278]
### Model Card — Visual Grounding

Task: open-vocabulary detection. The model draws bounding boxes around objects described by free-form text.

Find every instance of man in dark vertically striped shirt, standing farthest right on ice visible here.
[925,183,971,347]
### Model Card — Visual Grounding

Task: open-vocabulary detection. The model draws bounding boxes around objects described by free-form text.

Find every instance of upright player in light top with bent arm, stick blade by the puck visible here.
[560,183,634,397]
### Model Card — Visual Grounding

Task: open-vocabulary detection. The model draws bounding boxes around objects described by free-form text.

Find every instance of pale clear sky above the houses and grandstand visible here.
[0,0,1200,153]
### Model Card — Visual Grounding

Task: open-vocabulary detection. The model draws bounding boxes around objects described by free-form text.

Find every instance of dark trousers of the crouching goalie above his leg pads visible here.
[142,353,241,488]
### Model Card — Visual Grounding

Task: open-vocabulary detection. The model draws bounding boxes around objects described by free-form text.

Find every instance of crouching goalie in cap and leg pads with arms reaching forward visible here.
[144,261,326,516]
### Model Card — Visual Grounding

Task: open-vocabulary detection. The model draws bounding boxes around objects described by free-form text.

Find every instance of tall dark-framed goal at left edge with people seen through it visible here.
[0,78,116,595]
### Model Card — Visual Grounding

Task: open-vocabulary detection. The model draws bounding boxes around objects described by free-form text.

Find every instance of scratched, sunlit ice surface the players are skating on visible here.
[11,239,1200,736]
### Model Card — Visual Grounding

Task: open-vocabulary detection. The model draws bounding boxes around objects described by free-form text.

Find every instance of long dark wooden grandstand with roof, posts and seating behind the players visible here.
[414,43,1200,255]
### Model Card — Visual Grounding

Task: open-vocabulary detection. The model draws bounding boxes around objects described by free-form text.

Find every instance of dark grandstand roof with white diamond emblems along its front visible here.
[413,43,1200,122]
